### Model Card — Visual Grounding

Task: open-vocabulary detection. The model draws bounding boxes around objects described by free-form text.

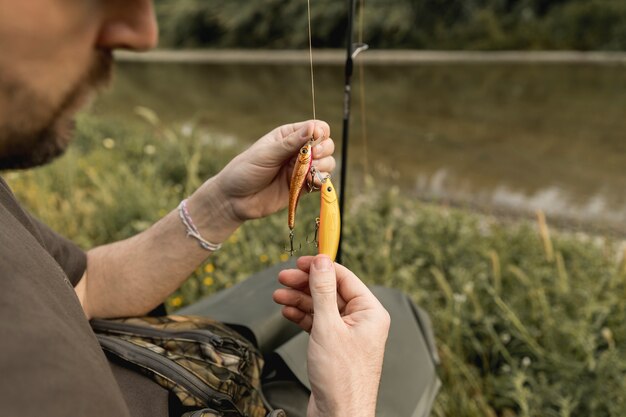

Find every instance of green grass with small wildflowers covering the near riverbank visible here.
[6,109,626,417]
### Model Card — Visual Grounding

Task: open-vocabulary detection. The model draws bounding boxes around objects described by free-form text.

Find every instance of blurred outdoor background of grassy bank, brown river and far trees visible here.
[8,0,626,417]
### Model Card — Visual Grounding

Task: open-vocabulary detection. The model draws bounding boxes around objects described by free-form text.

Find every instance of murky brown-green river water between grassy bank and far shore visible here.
[95,59,626,235]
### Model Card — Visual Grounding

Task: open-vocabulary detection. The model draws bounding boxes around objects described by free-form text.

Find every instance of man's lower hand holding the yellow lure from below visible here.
[274,255,390,417]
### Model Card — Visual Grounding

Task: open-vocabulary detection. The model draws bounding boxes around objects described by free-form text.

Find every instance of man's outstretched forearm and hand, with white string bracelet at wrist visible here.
[82,120,335,318]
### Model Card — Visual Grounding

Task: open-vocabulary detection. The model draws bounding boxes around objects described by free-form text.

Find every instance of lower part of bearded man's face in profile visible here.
[0,0,157,170]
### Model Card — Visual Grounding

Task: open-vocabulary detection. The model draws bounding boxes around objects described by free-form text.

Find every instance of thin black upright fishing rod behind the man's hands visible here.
[336,0,368,263]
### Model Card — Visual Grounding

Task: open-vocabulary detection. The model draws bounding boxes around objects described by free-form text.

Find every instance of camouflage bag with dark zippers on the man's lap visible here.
[91,316,285,417]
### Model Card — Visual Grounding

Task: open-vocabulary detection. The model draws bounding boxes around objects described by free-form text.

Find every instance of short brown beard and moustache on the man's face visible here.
[0,50,113,170]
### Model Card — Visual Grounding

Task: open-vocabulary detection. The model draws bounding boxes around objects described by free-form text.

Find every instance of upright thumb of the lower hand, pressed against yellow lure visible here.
[309,255,340,322]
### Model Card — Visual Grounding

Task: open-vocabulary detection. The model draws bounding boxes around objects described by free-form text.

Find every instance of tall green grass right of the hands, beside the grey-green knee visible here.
[345,189,626,416]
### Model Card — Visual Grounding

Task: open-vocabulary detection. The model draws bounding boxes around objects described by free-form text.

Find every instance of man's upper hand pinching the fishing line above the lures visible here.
[193,120,335,226]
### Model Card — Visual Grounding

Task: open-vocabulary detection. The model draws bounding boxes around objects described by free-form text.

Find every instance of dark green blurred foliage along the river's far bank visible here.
[156,0,626,50]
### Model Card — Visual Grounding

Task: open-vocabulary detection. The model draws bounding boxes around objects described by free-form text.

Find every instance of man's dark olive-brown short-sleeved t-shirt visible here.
[0,178,129,417]
